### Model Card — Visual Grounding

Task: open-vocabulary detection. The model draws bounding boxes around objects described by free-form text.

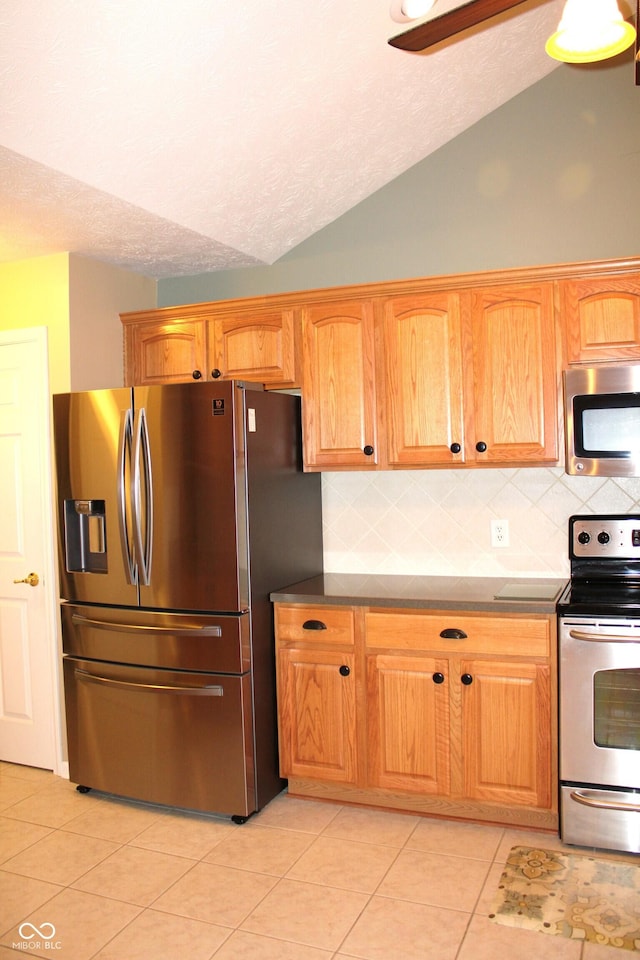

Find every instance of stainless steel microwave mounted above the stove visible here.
[564,363,640,477]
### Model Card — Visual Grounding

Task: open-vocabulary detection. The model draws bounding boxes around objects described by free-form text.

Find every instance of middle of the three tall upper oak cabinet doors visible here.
[382,293,464,466]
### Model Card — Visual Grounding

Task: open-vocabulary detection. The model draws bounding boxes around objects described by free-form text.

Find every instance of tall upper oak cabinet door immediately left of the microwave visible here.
[467,283,558,463]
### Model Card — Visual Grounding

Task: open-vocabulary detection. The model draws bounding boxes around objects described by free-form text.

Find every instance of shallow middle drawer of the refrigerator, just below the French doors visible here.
[61,603,250,673]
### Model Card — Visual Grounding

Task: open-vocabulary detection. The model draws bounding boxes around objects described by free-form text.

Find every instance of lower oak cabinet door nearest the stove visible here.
[460,659,551,808]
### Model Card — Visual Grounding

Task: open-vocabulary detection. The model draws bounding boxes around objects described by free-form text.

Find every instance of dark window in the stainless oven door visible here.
[593,668,640,750]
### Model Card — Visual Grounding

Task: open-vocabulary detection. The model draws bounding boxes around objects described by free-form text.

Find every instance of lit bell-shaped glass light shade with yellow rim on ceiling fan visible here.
[545,0,636,63]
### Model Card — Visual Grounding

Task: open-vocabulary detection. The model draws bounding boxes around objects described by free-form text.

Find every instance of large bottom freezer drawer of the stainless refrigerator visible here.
[64,657,256,816]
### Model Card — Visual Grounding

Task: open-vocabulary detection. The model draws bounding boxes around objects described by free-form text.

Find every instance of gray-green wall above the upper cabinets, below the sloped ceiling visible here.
[158,53,640,306]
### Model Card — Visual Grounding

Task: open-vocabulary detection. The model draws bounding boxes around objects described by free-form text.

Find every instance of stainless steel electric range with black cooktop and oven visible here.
[558,514,640,853]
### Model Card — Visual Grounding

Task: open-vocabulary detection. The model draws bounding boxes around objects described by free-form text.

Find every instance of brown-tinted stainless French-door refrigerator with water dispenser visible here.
[54,382,322,820]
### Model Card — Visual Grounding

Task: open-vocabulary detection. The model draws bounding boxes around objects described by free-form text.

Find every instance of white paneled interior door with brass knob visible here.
[0,327,60,770]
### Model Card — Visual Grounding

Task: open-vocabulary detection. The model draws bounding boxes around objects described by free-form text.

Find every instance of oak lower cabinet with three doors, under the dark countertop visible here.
[276,604,558,829]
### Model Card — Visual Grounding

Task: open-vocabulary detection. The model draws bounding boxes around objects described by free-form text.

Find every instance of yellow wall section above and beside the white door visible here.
[0,253,71,393]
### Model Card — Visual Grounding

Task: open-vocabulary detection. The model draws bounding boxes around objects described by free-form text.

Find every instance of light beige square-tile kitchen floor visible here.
[0,763,631,960]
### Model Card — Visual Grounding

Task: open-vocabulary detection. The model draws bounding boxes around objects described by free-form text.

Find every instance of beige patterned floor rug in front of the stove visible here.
[489,847,640,950]
